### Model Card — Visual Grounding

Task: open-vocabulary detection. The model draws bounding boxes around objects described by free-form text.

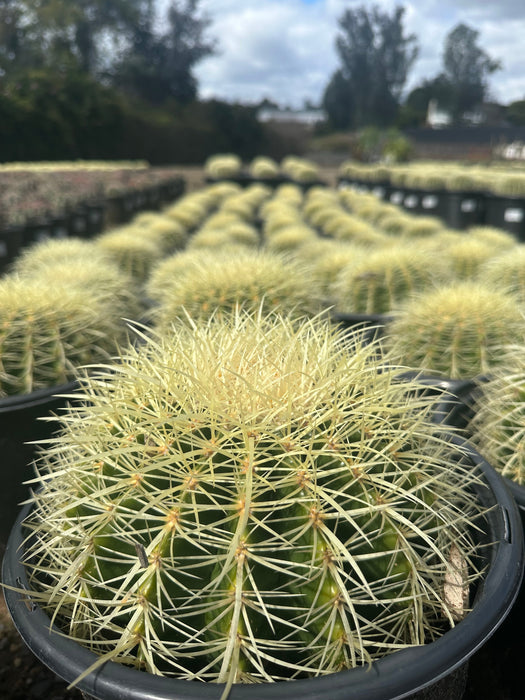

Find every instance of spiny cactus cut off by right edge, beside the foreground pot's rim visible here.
[468,345,525,486]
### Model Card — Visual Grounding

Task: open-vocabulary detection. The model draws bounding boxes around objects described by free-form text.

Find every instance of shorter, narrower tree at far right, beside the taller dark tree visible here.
[441,23,501,123]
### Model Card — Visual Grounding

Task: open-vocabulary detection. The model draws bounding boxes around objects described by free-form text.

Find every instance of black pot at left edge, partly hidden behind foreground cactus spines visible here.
[0,382,78,548]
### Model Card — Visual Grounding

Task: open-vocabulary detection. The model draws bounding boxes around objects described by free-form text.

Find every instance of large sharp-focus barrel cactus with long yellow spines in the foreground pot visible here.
[26,313,484,685]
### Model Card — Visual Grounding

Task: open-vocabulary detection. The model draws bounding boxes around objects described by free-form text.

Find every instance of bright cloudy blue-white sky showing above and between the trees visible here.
[159,0,525,108]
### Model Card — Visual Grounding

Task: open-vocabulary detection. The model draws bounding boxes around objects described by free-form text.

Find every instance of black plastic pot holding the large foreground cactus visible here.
[3,436,523,700]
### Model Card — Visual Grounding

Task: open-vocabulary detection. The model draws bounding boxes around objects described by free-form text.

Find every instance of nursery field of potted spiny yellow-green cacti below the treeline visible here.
[0,155,525,700]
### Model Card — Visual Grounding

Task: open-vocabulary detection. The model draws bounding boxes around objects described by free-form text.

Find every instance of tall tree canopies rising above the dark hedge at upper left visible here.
[0,0,215,104]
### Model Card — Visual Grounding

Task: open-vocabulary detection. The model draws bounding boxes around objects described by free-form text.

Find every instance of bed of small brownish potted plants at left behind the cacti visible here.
[0,162,184,270]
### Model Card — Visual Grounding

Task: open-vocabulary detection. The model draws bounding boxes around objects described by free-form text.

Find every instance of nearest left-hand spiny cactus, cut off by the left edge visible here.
[0,276,131,397]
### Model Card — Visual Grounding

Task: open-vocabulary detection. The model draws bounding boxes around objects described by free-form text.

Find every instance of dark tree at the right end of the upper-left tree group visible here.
[114,0,216,104]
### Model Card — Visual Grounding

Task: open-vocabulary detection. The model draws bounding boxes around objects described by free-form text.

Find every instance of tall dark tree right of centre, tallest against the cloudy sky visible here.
[323,5,418,127]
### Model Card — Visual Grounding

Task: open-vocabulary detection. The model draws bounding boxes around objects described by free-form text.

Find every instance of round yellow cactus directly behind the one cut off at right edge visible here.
[384,280,525,379]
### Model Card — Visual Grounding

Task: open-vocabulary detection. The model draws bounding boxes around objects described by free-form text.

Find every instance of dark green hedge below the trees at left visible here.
[0,71,271,165]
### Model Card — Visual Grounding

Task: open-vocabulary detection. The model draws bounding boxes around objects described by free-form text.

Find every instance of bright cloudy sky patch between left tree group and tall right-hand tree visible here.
[195,0,337,105]
